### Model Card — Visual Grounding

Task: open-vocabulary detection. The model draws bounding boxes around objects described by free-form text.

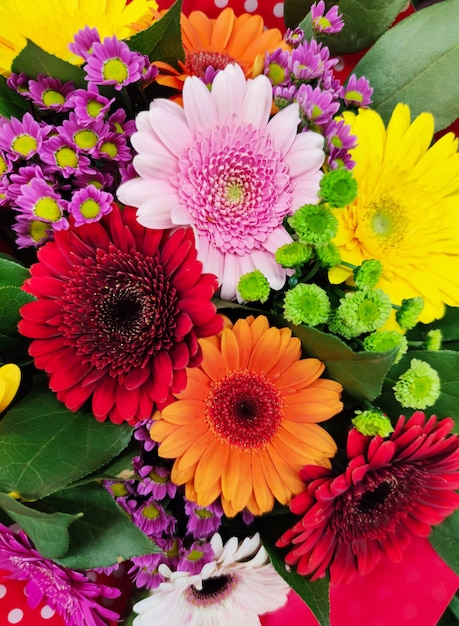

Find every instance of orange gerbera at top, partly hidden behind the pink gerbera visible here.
[155,8,288,91]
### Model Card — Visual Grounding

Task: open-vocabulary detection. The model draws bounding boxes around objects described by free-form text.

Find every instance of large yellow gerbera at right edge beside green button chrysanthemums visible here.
[329,104,459,323]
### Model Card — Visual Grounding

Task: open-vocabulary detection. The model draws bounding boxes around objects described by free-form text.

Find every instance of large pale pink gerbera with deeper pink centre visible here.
[118,65,324,299]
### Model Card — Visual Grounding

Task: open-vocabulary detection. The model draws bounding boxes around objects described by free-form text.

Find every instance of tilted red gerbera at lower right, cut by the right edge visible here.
[277,411,459,583]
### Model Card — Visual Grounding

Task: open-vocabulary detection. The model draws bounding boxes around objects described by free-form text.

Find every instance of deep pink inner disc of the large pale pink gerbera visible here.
[177,124,293,255]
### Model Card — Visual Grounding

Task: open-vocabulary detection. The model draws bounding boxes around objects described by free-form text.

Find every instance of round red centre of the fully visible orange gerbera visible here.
[206,370,282,448]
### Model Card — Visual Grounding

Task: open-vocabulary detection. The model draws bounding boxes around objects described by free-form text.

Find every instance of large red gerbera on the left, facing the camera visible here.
[19,204,223,424]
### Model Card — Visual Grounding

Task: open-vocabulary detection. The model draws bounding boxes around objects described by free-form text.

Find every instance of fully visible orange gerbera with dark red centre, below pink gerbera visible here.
[151,315,342,517]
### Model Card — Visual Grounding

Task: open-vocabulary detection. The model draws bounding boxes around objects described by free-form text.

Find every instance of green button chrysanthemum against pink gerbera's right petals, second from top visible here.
[288,204,338,246]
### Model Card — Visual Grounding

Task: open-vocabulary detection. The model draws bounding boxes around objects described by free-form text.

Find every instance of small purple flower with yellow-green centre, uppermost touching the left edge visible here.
[0,113,49,161]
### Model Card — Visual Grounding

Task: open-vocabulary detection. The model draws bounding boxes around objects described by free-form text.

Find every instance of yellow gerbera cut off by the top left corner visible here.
[0,0,158,74]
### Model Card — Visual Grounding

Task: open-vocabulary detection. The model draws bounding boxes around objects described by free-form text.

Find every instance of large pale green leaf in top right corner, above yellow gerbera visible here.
[352,0,459,131]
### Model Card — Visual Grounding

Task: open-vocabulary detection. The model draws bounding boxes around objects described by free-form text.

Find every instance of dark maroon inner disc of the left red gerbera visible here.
[61,248,178,375]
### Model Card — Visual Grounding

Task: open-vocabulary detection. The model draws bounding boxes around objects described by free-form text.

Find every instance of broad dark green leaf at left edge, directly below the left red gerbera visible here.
[0,385,132,500]
